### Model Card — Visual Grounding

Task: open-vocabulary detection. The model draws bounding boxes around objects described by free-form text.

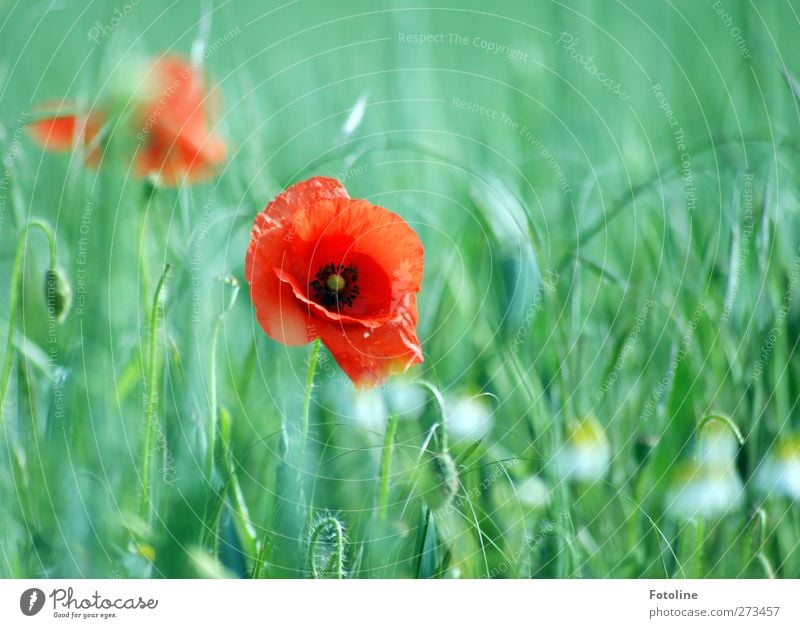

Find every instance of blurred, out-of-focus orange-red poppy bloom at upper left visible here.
[29,56,226,185]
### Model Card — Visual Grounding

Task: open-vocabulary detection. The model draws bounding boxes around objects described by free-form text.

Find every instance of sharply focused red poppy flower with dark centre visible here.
[245,177,423,388]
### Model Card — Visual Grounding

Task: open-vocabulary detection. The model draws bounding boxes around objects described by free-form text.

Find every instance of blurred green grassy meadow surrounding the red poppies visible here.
[0,0,800,577]
